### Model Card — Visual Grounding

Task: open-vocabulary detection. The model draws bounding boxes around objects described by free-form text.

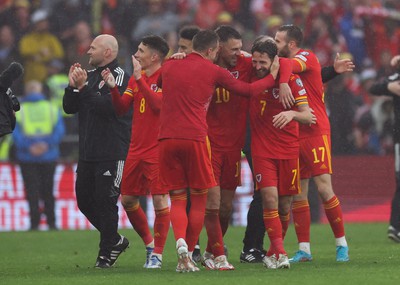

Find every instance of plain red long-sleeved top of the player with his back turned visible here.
[159,52,274,141]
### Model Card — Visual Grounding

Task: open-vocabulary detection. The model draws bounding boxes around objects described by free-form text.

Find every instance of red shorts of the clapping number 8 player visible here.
[121,158,168,196]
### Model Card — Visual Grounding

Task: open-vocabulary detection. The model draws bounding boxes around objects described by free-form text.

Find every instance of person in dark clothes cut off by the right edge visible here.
[369,55,400,243]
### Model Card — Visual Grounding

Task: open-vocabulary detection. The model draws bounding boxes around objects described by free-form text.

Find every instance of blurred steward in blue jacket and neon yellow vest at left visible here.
[13,81,64,230]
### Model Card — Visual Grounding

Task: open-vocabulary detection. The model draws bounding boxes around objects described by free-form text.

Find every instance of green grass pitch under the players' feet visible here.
[0,223,400,285]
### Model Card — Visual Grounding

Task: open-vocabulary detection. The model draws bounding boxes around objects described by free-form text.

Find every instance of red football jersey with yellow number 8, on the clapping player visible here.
[123,68,162,163]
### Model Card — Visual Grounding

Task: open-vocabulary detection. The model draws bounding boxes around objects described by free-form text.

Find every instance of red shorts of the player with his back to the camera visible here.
[159,139,217,191]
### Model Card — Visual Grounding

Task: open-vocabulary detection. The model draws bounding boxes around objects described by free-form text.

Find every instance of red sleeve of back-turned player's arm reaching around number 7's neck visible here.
[217,67,275,97]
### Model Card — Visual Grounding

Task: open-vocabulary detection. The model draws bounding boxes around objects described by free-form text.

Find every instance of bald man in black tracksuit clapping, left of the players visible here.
[63,35,131,268]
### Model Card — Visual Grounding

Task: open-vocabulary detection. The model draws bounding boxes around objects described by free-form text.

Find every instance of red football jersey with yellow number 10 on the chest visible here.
[207,55,252,151]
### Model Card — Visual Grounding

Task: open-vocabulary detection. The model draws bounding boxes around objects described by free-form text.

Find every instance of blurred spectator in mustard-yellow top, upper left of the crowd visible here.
[19,10,64,83]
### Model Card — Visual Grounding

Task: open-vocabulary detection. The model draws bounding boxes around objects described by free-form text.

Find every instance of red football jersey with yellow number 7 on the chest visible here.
[250,74,307,159]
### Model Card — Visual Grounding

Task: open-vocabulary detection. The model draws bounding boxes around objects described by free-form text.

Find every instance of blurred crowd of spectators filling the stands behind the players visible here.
[0,0,400,161]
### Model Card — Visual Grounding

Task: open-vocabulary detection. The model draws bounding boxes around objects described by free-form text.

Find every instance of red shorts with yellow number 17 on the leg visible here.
[299,135,332,179]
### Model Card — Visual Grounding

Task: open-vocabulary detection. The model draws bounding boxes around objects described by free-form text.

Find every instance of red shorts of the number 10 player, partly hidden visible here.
[211,148,242,191]
